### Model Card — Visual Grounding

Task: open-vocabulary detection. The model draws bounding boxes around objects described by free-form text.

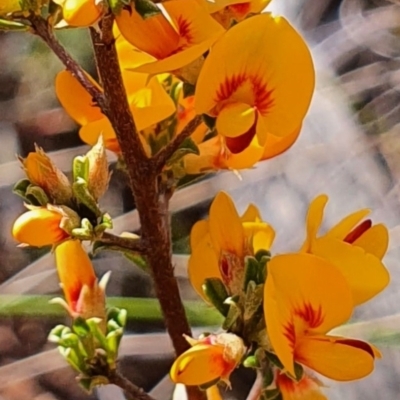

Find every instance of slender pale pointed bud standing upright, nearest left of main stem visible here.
[86,135,110,200]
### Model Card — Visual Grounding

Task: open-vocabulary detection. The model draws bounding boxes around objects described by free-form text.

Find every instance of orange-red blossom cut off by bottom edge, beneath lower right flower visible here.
[275,373,328,400]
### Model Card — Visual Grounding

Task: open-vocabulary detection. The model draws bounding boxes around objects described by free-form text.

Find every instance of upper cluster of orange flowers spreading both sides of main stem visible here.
[50,0,314,178]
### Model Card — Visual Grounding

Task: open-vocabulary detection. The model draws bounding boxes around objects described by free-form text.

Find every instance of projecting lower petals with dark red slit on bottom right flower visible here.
[296,336,374,381]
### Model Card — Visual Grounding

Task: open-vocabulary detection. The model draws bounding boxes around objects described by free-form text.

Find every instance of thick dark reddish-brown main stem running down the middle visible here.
[91,15,197,360]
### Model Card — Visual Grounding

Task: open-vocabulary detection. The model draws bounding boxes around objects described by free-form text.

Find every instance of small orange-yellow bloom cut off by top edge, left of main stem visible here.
[63,0,103,27]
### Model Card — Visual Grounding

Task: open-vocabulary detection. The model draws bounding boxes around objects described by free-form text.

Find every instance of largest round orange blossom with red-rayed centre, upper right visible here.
[195,13,314,165]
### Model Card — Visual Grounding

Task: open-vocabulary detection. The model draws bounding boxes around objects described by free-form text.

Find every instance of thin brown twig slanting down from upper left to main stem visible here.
[28,14,104,107]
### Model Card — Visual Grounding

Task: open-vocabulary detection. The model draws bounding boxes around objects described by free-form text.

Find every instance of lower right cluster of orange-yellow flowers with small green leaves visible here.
[171,192,389,399]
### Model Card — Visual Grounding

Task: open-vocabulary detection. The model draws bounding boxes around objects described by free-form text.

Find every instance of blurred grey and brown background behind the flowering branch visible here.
[0,0,400,400]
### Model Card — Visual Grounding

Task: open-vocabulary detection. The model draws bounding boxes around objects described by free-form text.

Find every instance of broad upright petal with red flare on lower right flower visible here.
[264,254,353,375]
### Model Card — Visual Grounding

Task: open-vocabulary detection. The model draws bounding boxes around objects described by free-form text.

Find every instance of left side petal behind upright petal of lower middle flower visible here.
[188,234,222,302]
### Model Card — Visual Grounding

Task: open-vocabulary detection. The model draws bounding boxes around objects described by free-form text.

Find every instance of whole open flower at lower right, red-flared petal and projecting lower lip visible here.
[264,253,380,381]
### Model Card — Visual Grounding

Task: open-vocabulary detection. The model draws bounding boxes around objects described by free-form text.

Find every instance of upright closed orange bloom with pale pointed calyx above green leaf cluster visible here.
[55,240,108,320]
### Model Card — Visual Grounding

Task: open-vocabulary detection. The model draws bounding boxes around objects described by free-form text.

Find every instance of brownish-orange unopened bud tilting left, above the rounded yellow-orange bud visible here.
[20,146,72,204]
